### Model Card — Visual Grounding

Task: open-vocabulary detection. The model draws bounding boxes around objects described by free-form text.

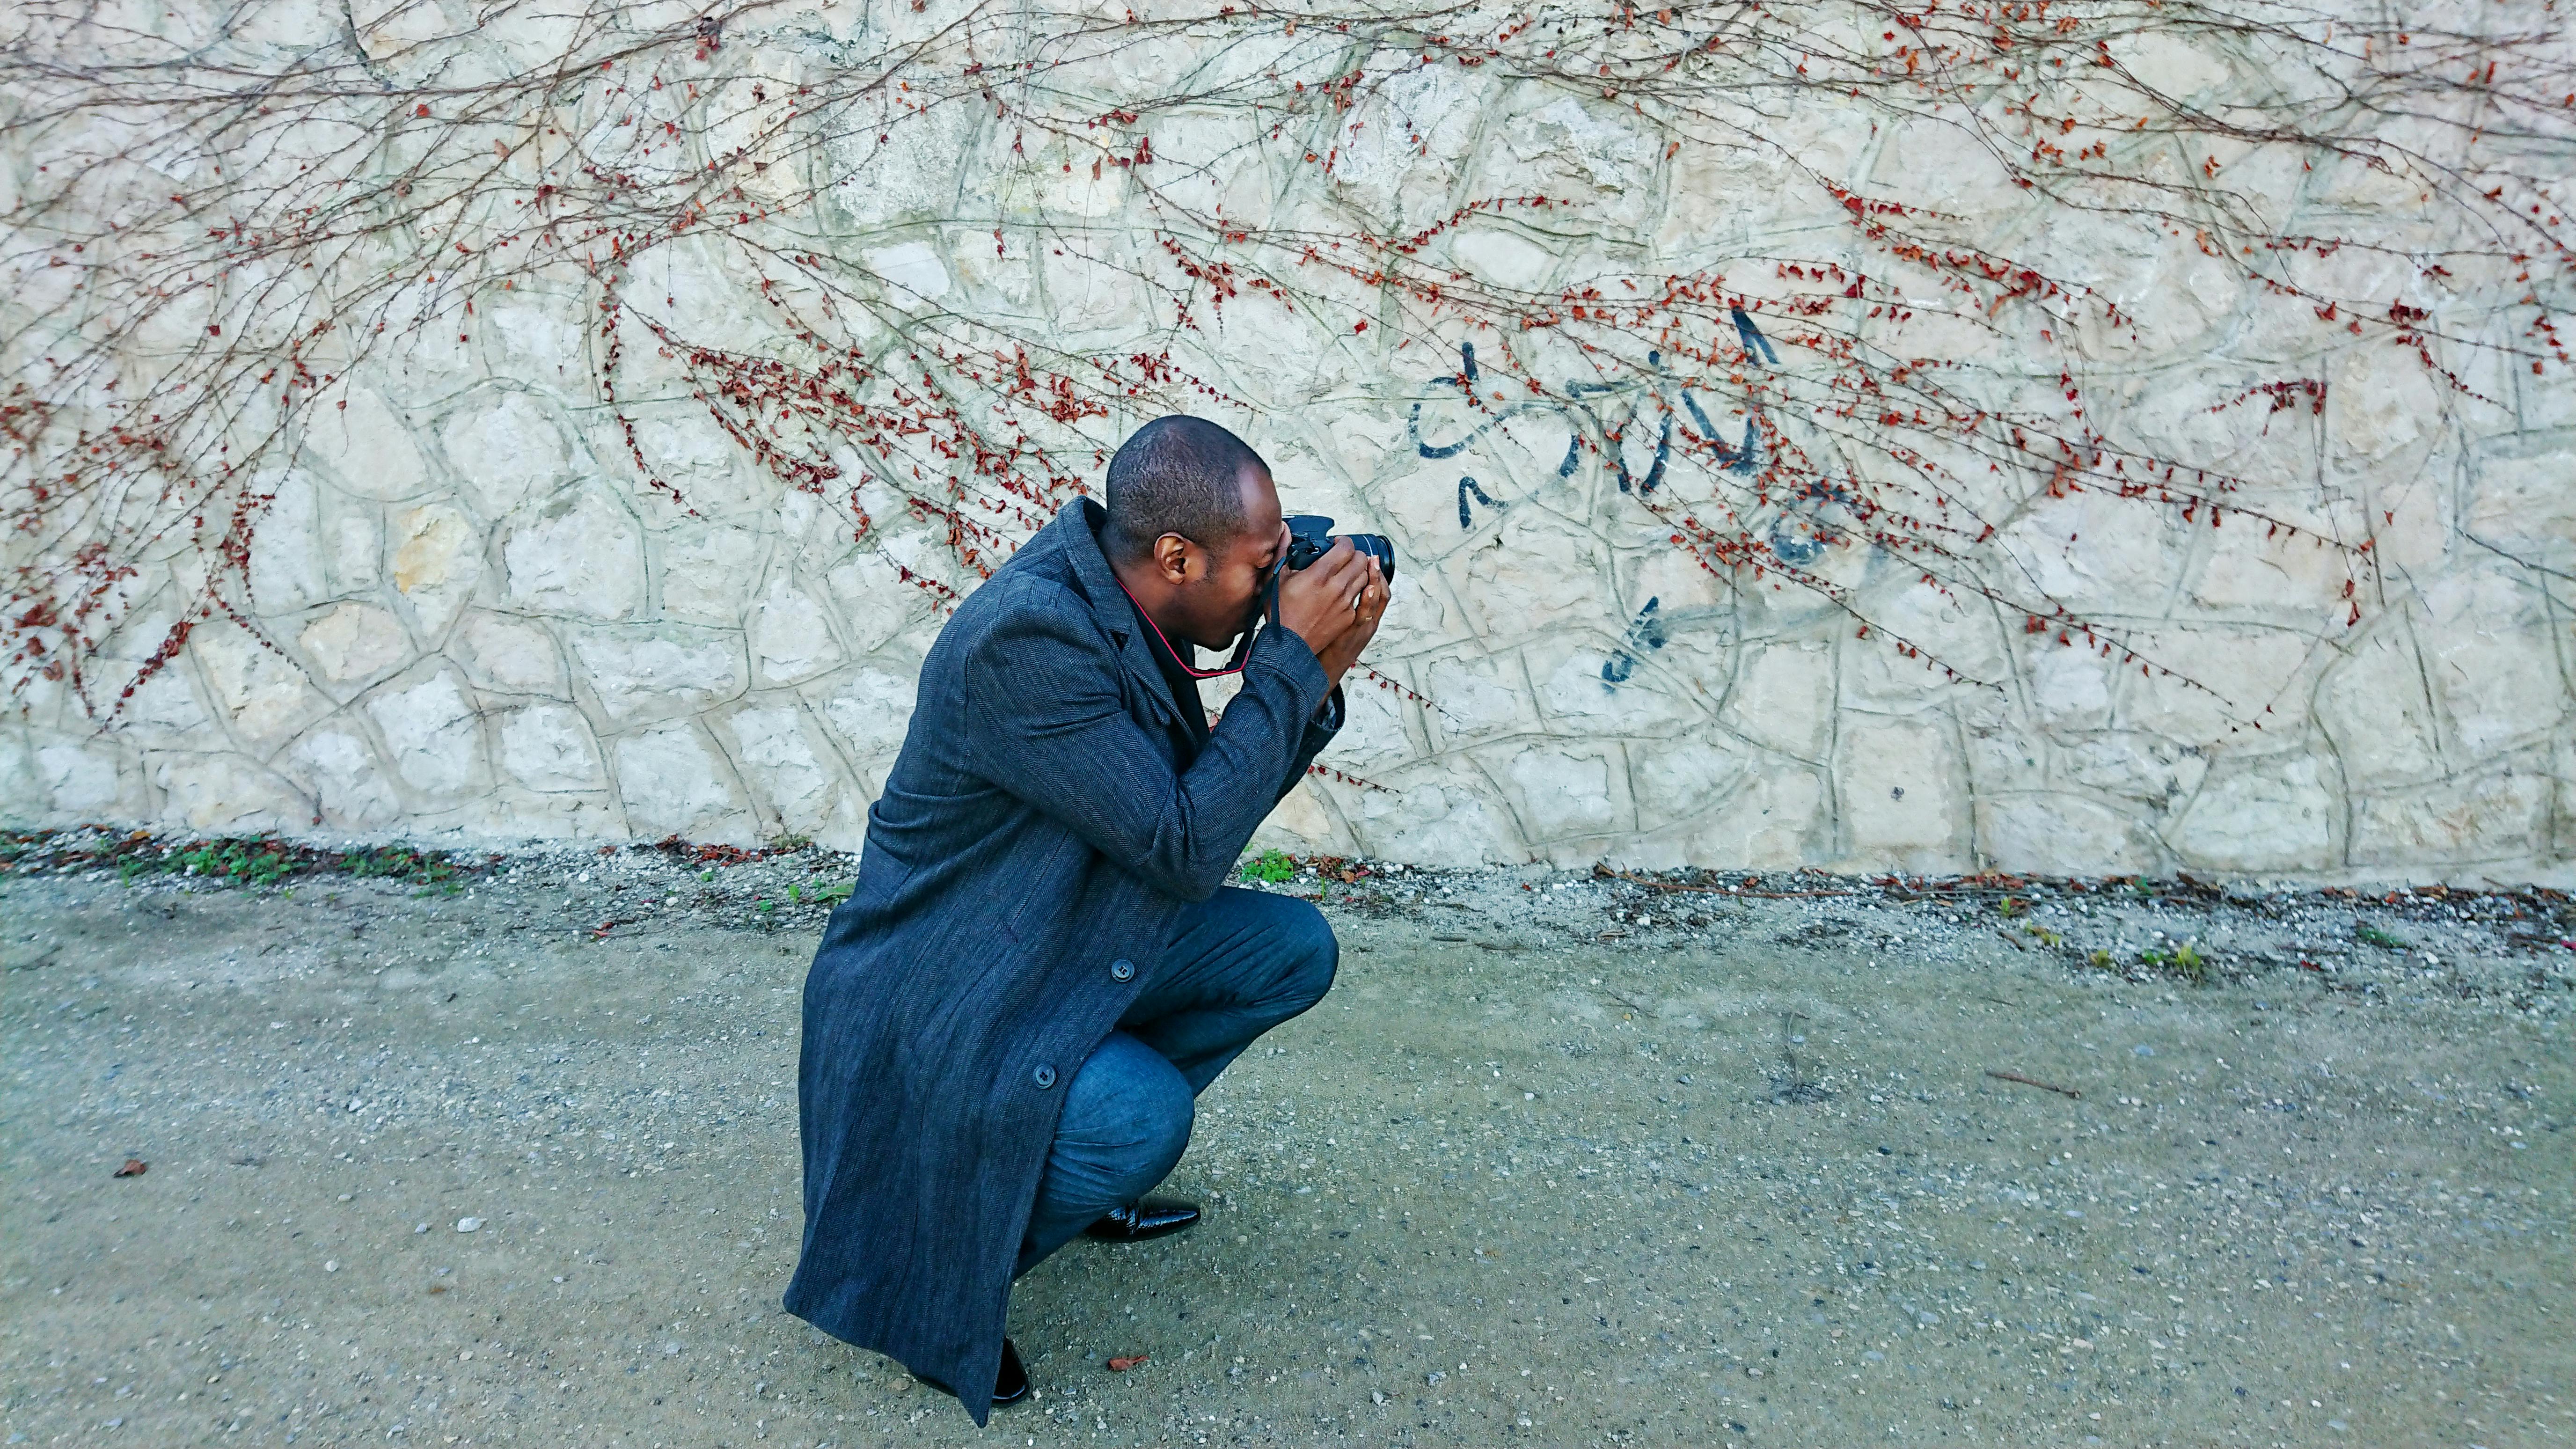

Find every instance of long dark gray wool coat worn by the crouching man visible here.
[786,500,1337,1426]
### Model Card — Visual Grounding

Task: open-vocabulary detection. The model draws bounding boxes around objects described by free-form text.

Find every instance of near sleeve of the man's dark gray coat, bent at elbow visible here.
[963,583,1327,900]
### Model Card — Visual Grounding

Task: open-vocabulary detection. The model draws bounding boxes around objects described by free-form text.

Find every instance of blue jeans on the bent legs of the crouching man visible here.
[1012,887,1342,1276]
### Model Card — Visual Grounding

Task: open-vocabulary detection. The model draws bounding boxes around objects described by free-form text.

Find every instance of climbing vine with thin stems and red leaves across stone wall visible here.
[0,0,2576,722]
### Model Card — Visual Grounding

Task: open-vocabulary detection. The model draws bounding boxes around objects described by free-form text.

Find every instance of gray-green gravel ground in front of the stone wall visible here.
[0,833,2576,1449]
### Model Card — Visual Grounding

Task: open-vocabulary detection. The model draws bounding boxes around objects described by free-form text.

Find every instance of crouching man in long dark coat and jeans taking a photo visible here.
[786,417,1386,1426]
